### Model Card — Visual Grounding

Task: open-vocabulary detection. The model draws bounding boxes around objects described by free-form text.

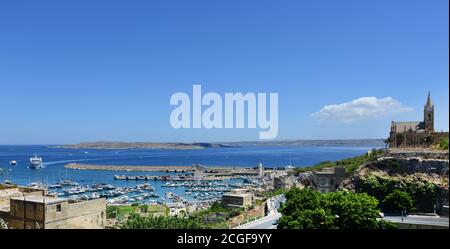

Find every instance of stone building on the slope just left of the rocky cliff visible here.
[311,167,348,193]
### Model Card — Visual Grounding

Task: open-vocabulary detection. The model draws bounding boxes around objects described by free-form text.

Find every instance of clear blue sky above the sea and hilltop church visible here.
[0,0,449,144]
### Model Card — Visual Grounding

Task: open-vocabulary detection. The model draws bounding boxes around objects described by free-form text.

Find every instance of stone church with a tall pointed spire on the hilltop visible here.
[388,92,448,148]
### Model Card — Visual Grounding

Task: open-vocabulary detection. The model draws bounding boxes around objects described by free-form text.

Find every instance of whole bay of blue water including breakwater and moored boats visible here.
[0,146,376,206]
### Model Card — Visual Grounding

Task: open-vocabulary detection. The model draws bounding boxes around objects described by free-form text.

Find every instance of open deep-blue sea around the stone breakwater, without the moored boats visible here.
[0,145,375,203]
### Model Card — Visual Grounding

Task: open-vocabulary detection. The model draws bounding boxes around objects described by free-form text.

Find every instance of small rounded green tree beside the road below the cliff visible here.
[382,189,414,213]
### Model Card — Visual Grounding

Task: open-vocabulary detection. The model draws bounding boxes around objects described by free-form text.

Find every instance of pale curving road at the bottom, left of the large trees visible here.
[235,196,286,229]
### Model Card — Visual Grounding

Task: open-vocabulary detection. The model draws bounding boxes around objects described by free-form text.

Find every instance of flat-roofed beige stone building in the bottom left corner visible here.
[0,185,106,229]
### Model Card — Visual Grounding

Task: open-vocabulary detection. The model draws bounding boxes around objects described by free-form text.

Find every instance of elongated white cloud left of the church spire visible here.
[311,97,412,123]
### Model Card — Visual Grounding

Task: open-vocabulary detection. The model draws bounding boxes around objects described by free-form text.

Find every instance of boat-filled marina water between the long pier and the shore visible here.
[19,179,258,205]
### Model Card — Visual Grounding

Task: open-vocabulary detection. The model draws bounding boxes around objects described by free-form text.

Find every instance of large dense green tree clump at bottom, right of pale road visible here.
[278,189,391,229]
